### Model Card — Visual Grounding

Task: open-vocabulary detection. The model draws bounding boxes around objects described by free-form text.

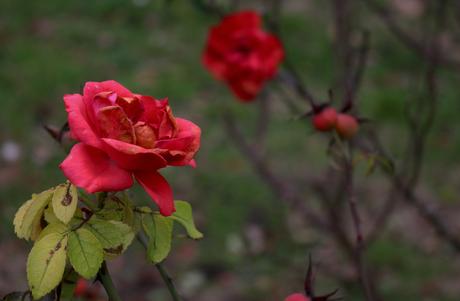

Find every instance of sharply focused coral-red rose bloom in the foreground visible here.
[60,81,201,215]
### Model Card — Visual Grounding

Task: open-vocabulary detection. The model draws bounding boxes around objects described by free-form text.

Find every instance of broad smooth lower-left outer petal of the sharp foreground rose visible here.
[59,143,133,193]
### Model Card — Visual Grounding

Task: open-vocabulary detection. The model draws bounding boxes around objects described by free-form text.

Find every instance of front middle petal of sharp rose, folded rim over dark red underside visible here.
[102,138,166,171]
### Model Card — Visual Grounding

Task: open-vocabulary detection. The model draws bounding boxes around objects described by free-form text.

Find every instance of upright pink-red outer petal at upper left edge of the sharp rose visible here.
[64,94,102,148]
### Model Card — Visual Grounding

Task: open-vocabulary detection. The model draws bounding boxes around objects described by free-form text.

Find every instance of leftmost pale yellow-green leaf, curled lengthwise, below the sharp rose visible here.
[13,189,53,240]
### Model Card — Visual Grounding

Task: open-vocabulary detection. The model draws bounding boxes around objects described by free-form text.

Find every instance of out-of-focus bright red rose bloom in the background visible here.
[203,11,284,101]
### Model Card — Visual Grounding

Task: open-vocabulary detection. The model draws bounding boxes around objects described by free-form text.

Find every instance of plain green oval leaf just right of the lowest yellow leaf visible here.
[68,228,104,279]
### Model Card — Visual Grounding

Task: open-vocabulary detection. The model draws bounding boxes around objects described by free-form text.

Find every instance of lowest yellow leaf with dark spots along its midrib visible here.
[27,233,67,299]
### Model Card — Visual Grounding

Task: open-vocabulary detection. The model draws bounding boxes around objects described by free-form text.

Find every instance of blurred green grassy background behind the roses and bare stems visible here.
[0,0,460,301]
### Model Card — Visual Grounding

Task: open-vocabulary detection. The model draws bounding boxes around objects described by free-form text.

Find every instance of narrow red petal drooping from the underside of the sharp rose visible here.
[134,171,176,216]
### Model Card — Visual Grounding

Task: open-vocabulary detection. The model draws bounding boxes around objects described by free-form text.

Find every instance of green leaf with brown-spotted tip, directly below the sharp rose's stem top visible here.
[84,218,134,257]
